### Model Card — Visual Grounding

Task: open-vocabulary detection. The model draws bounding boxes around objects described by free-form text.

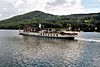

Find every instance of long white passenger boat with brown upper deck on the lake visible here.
[19,24,79,39]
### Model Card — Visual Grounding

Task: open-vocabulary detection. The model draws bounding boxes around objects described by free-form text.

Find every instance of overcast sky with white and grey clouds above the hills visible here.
[0,0,100,20]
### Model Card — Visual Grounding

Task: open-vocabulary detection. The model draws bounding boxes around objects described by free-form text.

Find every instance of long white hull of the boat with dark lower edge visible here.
[19,32,77,39]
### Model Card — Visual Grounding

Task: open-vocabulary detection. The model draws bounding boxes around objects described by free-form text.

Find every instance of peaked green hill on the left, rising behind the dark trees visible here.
[0,11,60,29]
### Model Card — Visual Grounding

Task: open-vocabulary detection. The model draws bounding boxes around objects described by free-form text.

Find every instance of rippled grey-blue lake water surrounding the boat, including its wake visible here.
[0,30,100,67]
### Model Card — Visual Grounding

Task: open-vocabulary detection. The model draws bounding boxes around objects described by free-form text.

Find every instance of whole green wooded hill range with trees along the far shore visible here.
[0,11,100,31]
